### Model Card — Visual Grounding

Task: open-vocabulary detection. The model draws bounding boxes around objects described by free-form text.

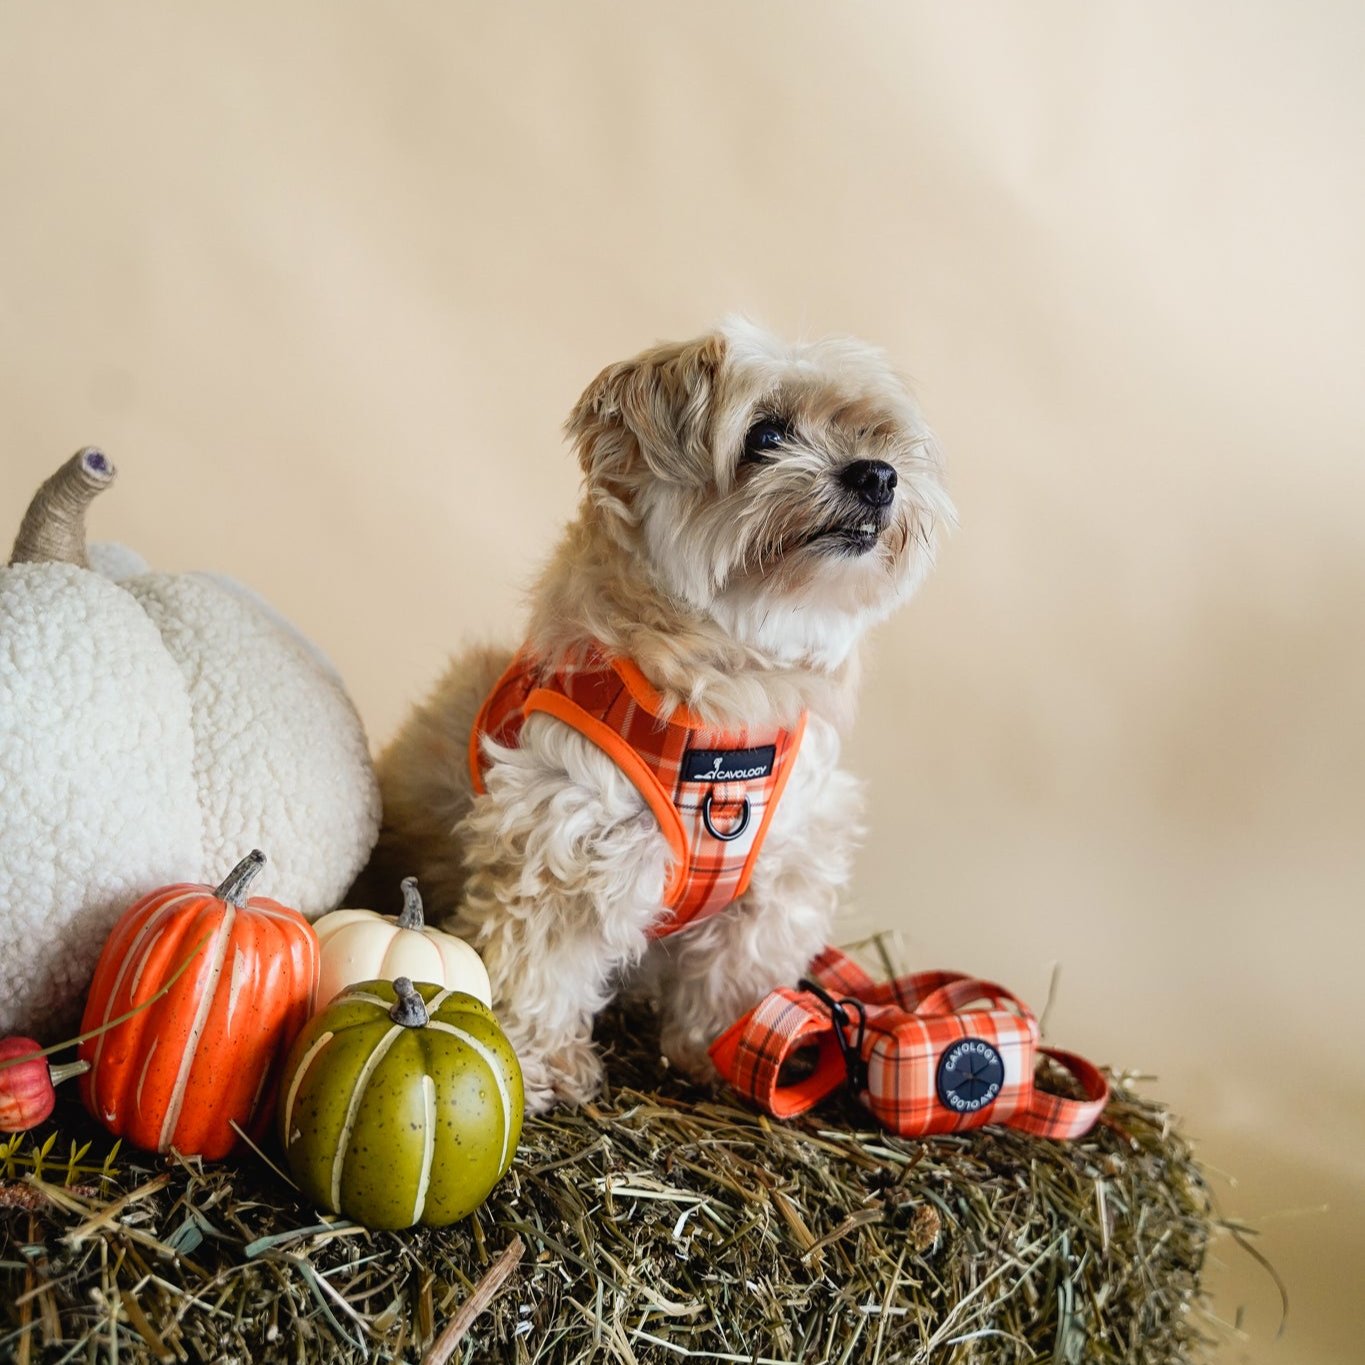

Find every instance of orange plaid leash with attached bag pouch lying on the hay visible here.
[711,949,1110,1138]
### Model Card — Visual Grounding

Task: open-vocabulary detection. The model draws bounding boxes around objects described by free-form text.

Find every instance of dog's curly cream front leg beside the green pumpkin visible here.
[453,717,667,1114]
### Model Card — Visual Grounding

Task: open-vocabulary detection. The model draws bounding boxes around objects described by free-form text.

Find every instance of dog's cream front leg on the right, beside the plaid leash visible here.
[646,718,861,1081]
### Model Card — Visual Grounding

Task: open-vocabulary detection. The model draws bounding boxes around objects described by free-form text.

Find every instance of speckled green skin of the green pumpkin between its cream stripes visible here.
[277,981,524,1229]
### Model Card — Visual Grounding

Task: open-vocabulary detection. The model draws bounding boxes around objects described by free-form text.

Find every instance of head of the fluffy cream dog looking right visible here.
[568,322,953,662]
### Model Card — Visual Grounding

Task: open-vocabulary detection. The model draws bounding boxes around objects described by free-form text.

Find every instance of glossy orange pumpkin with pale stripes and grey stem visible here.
[79,852,318,1159]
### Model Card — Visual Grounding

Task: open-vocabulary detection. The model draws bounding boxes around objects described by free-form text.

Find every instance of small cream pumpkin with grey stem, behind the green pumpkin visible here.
[313,876,493,1006]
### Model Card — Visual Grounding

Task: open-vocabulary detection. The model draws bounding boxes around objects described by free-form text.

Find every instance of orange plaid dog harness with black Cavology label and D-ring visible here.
[470,648,805,938]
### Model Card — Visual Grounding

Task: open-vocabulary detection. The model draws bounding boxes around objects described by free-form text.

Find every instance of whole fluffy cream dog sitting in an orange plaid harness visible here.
[375,322,953,1112]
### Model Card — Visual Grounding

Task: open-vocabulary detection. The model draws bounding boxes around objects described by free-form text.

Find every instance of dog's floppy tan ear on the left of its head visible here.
[565,333,725,504]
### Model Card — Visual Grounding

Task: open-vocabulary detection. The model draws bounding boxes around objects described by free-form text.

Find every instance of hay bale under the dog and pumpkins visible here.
[0,1014,1211,1365]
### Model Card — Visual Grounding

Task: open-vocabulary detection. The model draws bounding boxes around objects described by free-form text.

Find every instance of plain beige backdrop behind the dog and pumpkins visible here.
[0,0,1365,1365]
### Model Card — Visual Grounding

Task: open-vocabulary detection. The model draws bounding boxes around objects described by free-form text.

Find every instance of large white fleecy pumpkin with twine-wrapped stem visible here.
[0,449,379,1036]
